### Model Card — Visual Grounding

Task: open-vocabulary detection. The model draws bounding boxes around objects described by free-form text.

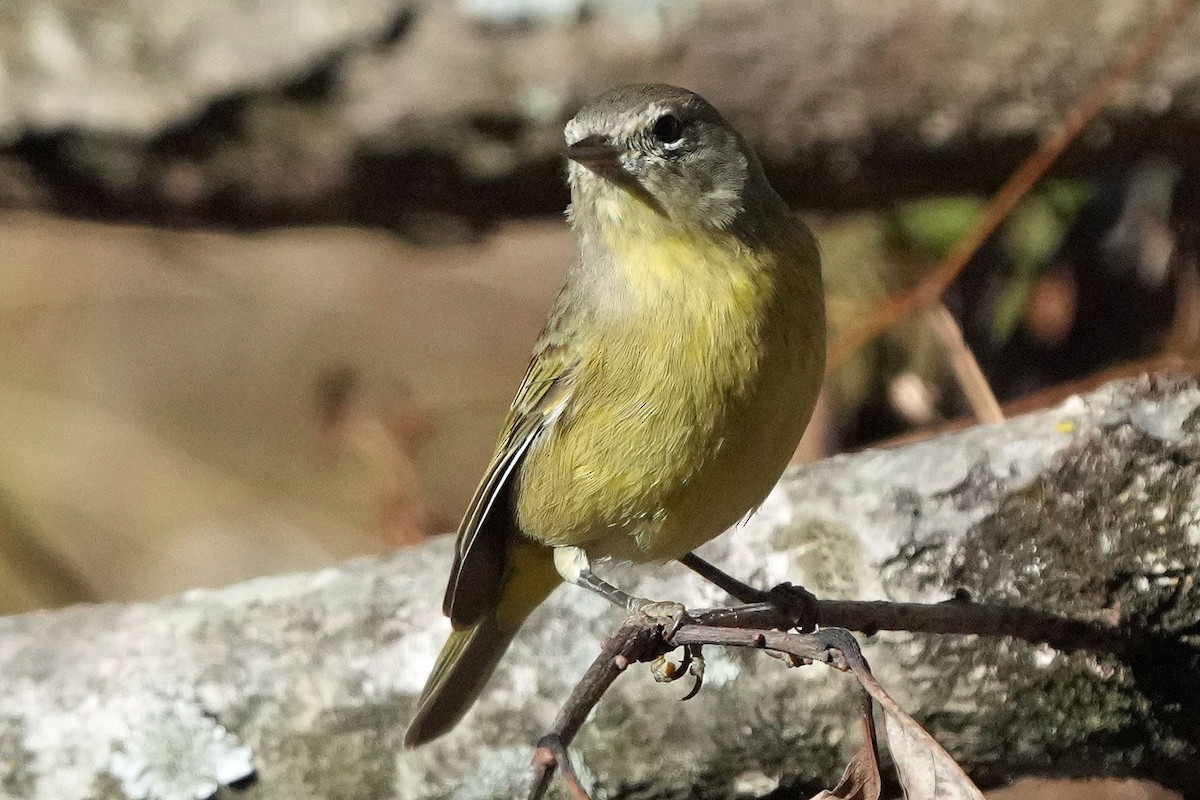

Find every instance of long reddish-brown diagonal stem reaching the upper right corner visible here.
[827,0,1196,372]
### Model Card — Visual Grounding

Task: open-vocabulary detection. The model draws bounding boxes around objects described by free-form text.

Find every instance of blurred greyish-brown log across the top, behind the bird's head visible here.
[0,0,1200,227]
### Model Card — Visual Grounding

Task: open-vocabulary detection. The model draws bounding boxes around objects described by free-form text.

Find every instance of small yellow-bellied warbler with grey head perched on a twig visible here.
[404,85,826,746]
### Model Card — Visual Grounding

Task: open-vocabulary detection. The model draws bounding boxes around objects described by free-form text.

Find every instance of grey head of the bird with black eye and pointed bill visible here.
[565,84,774,229]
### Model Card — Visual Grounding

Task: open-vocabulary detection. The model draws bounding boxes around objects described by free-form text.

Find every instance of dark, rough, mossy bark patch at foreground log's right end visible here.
[890,386,1200,776]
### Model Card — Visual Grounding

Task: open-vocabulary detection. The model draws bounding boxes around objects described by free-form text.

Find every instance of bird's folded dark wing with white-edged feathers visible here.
[442,320,578,627]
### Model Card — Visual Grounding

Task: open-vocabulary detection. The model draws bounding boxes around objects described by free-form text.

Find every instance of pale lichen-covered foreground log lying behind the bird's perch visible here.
[0,380,1200,800]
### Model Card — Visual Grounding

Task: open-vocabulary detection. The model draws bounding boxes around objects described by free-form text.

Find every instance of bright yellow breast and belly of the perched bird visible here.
[517,221,824,561]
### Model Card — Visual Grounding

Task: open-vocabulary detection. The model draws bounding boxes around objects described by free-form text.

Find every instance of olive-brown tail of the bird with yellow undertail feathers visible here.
[404,541,563,747]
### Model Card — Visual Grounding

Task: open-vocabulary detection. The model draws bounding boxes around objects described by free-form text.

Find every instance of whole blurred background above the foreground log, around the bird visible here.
[0,0,1200,613]
